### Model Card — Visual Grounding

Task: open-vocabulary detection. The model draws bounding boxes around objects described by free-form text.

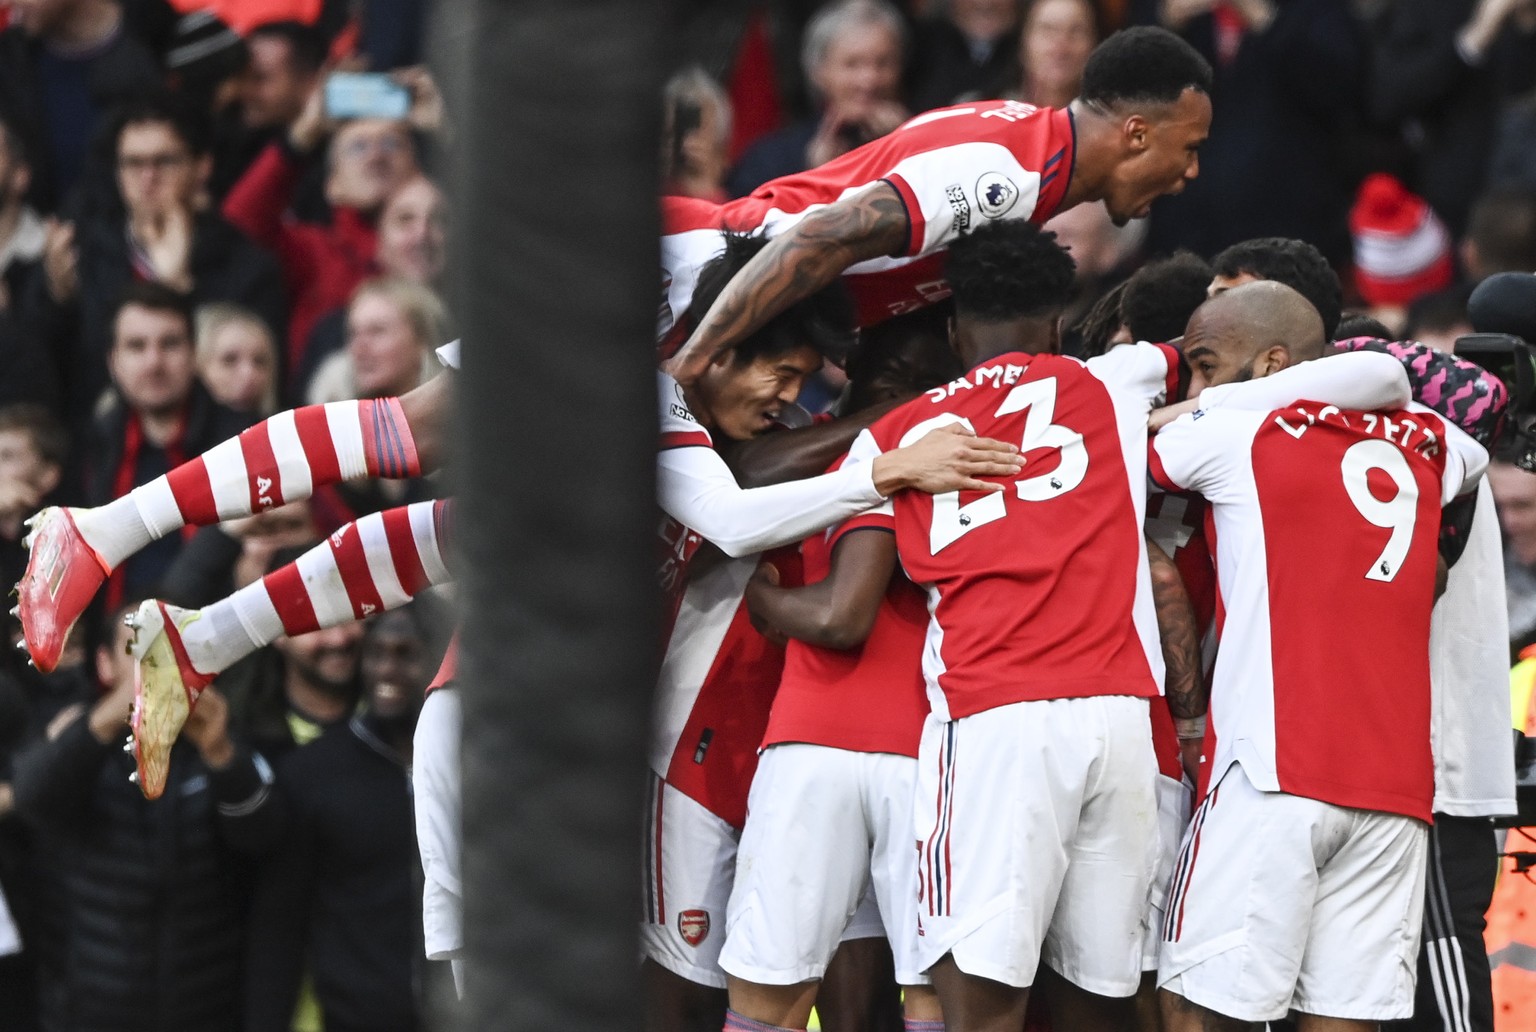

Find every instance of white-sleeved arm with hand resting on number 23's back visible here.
[656,425,1023,557]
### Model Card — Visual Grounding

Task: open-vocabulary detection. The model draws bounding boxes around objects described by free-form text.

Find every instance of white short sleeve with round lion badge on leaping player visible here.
[882,141,1040,256]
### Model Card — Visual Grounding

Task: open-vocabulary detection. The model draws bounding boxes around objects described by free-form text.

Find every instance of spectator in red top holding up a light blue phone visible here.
[224,69,442,369]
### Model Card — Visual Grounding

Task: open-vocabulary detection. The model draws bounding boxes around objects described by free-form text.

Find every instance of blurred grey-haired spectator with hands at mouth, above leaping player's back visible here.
[728,0,908,197]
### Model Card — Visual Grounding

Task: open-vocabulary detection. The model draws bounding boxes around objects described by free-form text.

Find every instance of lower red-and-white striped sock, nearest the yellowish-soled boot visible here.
[175,502,452,674]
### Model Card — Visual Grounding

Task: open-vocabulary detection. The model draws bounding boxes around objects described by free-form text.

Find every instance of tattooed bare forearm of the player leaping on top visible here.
[667,183,911,385]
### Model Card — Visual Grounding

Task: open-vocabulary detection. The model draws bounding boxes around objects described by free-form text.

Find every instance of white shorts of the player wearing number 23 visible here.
[915,696,1157,997]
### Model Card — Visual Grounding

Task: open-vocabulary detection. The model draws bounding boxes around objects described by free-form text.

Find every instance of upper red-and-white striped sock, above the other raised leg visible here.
[75,398,421,568]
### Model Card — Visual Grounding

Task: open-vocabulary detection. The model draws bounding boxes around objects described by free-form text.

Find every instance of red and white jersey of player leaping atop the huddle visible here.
[657,100,1077,339]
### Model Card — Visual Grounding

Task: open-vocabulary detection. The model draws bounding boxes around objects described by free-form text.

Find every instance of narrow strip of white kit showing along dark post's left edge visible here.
[410,688,464,960]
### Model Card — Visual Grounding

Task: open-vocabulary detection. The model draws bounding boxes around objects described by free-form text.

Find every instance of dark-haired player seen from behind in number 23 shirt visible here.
[749,221,1178,1029]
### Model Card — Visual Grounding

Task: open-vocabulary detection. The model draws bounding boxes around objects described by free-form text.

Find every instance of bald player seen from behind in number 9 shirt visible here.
[1152,283,1487,1032]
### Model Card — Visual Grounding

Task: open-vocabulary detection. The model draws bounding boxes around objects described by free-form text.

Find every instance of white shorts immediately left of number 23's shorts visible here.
[720,743,928,986]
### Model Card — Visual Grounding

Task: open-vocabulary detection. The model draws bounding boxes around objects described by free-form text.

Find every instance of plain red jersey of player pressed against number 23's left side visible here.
[763,500,928,759]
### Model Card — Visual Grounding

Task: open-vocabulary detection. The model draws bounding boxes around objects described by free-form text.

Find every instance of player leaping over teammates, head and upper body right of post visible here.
[660,28,1210,384]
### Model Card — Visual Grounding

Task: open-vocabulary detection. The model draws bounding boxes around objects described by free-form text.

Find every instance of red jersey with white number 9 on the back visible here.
[1150,399,1487,820]
